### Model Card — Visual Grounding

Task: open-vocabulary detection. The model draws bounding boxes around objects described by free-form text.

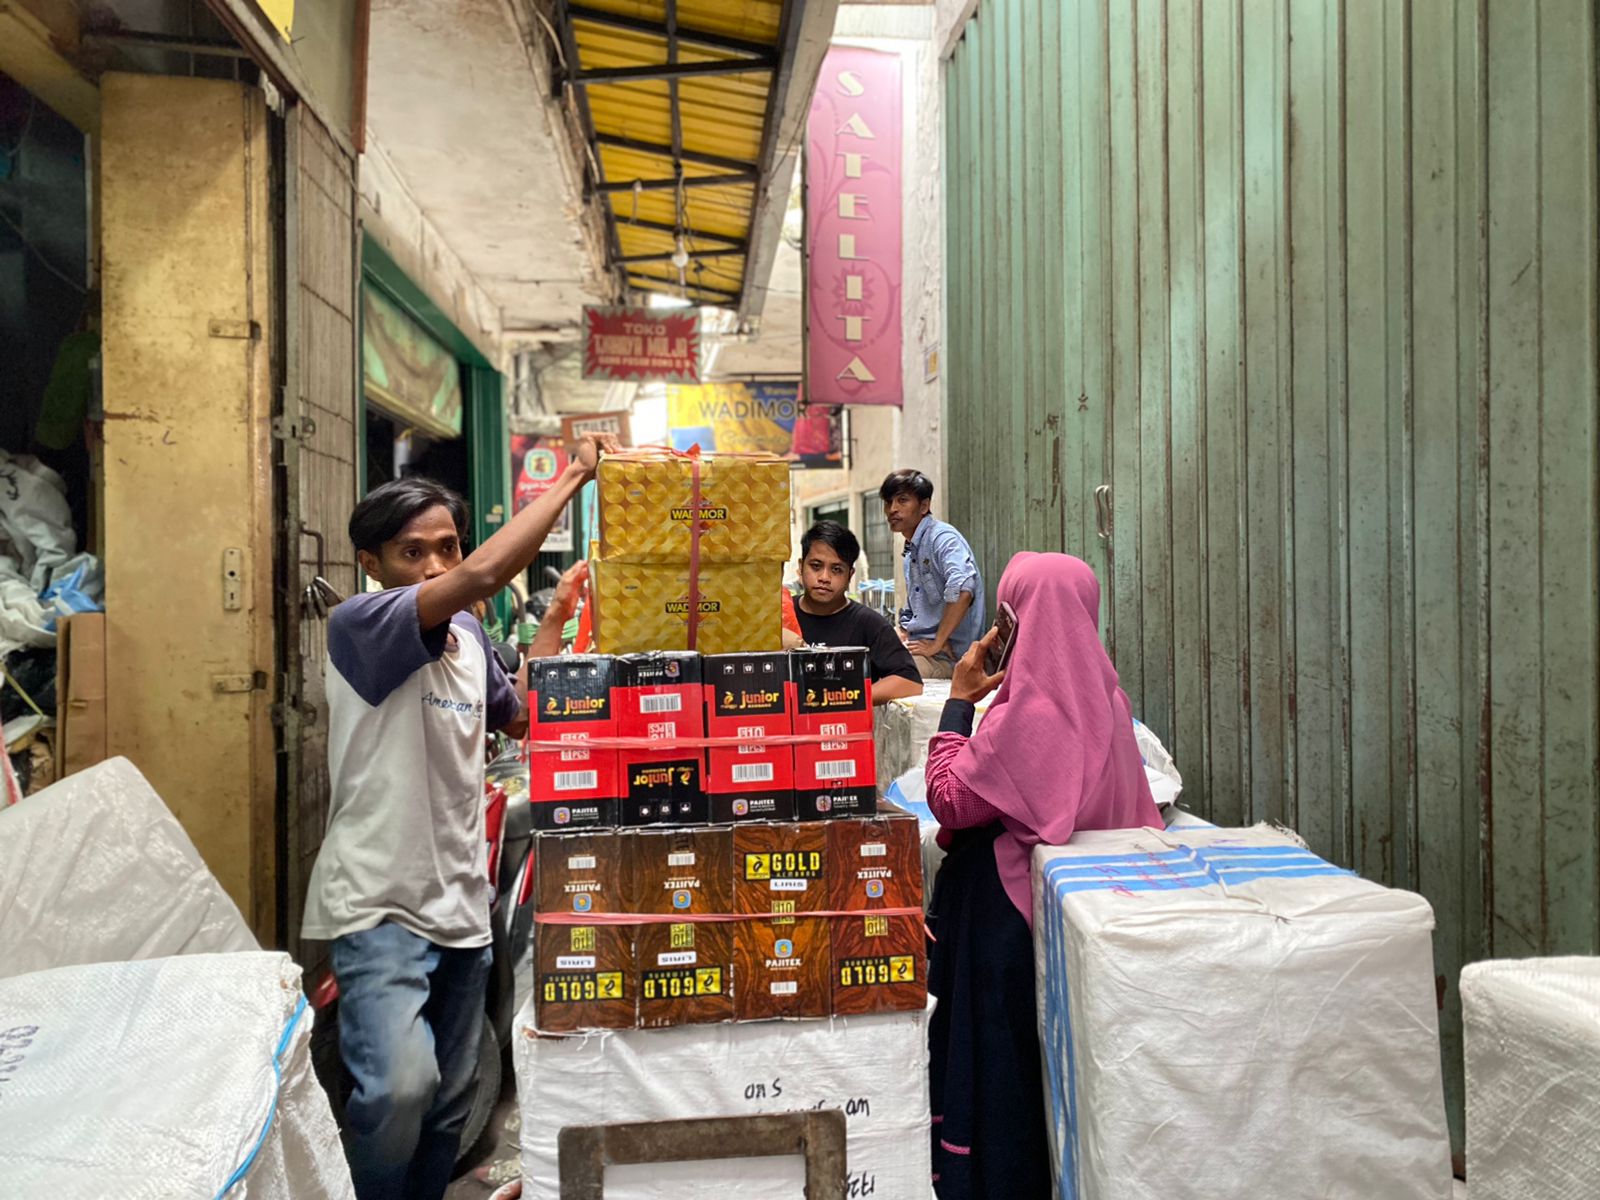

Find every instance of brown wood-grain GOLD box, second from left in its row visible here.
[624,827,734,1029]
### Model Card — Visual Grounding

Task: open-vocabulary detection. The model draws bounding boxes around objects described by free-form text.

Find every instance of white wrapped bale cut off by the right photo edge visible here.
[1461,958,1600,1200]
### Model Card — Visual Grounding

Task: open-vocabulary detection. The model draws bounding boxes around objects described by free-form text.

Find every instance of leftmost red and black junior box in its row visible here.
[528,654,619,829]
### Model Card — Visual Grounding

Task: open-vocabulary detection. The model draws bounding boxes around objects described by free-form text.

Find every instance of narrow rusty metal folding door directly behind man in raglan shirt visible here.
[274,104,360,971]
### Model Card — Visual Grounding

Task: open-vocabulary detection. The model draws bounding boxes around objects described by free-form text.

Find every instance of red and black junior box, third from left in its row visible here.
[704,653,795,822]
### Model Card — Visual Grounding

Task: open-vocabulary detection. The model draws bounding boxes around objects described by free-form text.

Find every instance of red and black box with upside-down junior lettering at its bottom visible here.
[611,651,710,826]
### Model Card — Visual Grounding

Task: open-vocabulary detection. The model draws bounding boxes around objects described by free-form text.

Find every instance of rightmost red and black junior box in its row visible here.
[790,646,878,821]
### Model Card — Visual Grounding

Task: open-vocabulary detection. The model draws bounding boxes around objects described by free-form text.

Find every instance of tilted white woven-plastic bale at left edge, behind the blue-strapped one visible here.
[0,758,258,978]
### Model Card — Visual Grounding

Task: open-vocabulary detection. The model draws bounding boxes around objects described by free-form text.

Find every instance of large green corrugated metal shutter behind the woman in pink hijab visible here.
[946,0,1600,1146]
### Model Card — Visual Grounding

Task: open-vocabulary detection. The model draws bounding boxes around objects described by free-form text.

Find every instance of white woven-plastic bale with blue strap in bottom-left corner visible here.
[0,952,355,1200]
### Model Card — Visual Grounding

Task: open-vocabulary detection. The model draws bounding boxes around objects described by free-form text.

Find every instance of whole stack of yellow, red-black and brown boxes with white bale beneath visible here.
[517,454,930,1197]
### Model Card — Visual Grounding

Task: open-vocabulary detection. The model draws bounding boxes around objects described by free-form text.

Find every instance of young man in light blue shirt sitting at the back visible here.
[878,470,986,678]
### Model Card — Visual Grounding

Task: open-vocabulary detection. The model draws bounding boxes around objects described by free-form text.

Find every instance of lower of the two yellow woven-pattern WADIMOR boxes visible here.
[589,560,784,654]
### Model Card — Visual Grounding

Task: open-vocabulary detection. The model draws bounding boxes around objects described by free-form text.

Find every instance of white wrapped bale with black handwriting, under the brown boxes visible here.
[515,1008,933,1200]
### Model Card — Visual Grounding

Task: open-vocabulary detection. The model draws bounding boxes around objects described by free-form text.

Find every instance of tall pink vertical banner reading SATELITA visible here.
[805,46,904,405]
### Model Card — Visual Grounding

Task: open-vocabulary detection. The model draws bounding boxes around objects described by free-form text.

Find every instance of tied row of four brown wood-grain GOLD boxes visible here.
[534,810,928,1034]
